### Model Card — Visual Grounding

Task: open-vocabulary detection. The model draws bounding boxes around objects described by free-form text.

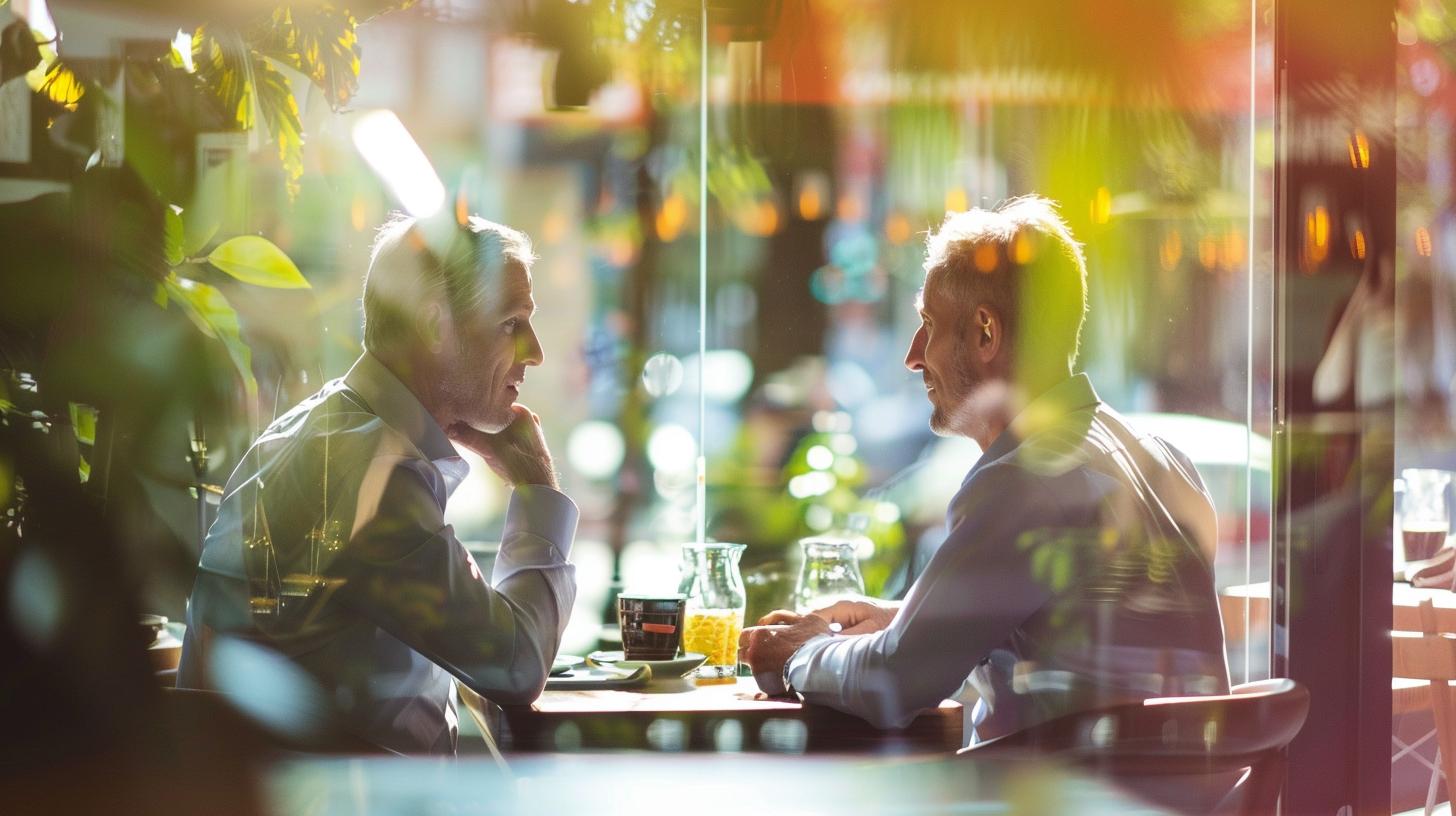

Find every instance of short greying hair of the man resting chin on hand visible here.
[364,213,536,351]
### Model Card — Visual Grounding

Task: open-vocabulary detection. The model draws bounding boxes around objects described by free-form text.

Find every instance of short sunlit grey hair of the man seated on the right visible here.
[925,195,1088,369]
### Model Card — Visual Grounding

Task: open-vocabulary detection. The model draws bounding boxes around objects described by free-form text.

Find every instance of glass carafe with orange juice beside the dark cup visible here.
[683,542,747,678]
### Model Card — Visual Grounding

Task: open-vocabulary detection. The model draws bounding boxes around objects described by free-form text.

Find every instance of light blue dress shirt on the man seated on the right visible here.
[785,374,1229,742]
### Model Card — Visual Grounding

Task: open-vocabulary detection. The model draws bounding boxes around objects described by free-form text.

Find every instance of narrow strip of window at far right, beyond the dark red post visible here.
[1391,1,1456,812]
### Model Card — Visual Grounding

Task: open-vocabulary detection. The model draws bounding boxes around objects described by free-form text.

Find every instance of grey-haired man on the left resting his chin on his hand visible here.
[178,209,577,753]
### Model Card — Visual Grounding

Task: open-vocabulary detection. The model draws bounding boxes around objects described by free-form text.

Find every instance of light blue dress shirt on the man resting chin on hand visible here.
[178,353,577,753]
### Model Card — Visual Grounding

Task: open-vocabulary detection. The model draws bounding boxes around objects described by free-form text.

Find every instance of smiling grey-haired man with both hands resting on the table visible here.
[740,197,1229,742]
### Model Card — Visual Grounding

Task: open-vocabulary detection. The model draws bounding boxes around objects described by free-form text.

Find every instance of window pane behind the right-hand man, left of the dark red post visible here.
[706,1,1273,682]
